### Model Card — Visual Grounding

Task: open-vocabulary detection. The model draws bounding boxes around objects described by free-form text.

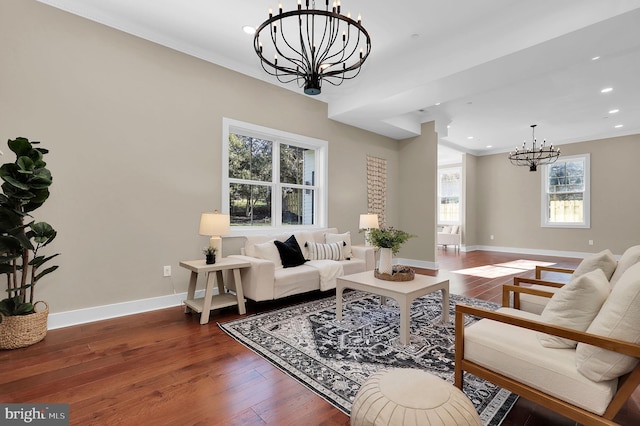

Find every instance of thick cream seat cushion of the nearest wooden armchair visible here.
[464,308,618,415]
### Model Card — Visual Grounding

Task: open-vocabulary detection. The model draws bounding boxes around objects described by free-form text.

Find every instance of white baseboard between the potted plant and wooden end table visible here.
[47,289,208,330]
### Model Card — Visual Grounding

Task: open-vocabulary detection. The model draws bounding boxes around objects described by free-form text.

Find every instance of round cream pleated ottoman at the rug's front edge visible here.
[351,368,482,426]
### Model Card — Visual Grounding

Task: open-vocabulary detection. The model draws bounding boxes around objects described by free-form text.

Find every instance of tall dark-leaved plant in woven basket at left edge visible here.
[0,137,58,349]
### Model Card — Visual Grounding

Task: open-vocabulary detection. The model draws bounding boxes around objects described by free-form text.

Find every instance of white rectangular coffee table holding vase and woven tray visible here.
[336,271,449,345]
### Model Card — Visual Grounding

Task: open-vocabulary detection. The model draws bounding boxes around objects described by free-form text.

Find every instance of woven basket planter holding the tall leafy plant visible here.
[0,301,49,349]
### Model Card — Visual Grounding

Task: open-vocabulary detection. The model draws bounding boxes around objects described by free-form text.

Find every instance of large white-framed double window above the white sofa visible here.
[222,118,328,230]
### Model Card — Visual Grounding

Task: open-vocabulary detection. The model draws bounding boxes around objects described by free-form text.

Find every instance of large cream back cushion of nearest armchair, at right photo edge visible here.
[576,263,640,382]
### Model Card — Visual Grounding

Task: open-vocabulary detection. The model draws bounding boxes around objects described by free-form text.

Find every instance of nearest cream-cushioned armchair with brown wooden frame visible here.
[454,264,640,425]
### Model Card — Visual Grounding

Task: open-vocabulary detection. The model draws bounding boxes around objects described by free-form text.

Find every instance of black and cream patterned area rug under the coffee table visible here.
[219,291,517,426]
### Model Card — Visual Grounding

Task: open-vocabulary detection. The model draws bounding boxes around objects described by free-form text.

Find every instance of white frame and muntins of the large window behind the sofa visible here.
[221,117,329,236]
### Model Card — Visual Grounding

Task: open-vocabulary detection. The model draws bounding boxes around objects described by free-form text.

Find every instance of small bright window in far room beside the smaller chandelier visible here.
[542,154,590,228]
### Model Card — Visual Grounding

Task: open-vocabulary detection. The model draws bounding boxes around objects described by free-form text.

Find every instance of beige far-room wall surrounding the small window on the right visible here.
[467,135,640,254]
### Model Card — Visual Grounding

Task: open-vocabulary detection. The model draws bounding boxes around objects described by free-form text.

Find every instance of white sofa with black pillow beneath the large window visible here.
[229,228,375,302]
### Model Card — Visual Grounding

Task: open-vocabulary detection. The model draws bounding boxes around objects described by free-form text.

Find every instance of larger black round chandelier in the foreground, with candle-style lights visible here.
[253,0,371,95]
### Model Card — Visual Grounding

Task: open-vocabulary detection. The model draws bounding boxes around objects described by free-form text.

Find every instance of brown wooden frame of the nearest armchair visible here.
[454,304,640,425]
